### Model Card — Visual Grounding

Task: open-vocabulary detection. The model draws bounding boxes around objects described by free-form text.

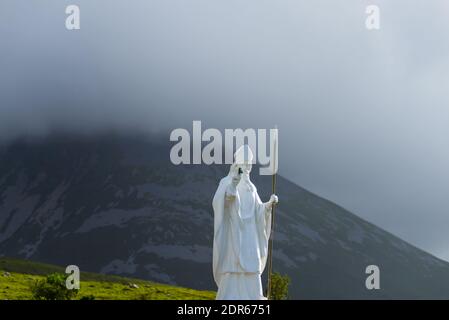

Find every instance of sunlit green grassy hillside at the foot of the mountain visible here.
[0,258,215,300]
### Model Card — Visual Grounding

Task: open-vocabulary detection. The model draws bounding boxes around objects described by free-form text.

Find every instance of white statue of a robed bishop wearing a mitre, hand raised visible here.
[212,145,278,300]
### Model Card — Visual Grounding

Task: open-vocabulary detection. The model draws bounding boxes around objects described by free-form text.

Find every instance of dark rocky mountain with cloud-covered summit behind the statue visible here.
[0,135,449,299]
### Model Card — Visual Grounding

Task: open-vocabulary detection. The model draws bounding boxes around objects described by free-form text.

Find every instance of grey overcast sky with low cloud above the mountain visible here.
[0,0,449,260]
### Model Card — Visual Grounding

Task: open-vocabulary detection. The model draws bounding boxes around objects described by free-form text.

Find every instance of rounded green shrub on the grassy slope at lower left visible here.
[31,273,78,300]
